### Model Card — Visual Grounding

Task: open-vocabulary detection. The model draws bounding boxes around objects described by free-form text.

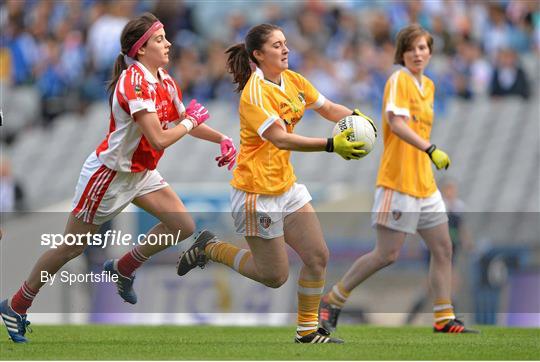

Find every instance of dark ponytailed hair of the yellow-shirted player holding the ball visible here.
[225,24,283,93]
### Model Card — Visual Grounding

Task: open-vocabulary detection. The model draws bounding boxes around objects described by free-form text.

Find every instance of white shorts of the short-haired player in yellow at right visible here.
[371,187,448,234]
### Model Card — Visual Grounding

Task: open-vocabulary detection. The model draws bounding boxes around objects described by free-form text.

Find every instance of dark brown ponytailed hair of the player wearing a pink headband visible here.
[107,13,158,105]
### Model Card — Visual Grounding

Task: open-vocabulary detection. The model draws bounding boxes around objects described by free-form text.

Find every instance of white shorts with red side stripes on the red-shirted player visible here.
[71,152,168,225]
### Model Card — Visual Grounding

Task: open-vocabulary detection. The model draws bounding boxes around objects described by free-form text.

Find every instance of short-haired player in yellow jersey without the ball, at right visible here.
[321,24,475,333]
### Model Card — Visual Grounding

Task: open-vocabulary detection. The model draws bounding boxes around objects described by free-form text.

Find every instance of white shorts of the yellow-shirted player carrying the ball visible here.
[231,183,311,239]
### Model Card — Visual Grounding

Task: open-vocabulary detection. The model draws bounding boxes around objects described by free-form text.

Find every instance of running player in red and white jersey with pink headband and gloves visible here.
[0,13,236,342]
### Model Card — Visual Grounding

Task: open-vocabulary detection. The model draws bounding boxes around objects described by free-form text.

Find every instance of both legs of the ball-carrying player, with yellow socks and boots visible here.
[178,204,342,343]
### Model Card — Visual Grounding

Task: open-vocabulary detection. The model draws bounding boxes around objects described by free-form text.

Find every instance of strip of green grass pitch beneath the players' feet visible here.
[0,325,540,360]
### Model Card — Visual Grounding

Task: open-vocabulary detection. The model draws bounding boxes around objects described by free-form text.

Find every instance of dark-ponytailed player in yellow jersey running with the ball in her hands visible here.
[178,24,370,343]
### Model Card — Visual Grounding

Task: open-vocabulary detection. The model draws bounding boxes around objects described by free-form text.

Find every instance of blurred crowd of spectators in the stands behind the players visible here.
[0,0,540,132]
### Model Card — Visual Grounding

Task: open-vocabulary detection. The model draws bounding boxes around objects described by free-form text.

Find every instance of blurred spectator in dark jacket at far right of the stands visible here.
[490,48,530,99]
